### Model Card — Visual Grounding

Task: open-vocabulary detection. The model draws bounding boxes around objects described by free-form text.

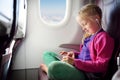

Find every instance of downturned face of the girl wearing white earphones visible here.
[77,17,99,34]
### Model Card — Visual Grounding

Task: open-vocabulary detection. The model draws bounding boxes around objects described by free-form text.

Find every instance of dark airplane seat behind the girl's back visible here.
[96,0,120,80]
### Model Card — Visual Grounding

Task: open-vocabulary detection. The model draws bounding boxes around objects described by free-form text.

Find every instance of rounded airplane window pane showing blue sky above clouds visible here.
[40,0,67,24]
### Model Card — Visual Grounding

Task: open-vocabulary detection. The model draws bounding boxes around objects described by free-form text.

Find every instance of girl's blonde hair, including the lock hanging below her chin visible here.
[78,4,102,44]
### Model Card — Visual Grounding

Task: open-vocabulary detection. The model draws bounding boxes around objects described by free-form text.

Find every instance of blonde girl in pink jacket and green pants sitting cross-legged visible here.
[40,4,114,80]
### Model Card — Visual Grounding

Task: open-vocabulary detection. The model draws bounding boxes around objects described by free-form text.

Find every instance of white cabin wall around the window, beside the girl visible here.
[13,0,86,69]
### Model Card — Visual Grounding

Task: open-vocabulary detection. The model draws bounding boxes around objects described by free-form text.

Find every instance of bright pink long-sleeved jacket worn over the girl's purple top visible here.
[74,31,114,73]
